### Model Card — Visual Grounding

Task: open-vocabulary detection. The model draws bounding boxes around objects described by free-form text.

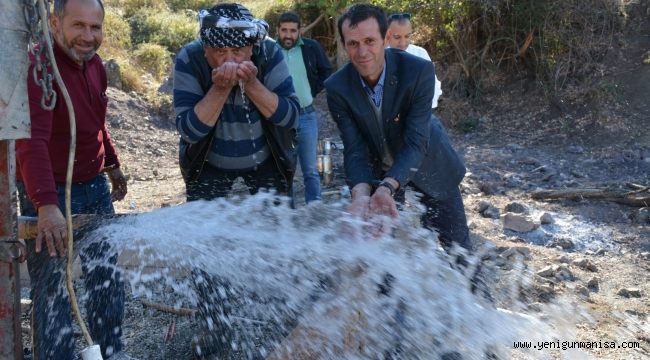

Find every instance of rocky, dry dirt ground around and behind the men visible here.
[17,2,650,359]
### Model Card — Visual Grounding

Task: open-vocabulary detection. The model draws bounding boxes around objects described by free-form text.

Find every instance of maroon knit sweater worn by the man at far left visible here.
[16,42,119,209]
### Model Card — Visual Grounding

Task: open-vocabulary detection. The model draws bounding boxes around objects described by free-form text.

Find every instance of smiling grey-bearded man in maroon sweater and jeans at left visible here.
[16,0,127,359]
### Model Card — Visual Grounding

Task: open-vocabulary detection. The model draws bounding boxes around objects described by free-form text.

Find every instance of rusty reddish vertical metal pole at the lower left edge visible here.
[0,140,23,360]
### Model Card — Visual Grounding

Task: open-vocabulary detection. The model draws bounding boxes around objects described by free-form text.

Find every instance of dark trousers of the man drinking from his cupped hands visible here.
[185,159,291,201]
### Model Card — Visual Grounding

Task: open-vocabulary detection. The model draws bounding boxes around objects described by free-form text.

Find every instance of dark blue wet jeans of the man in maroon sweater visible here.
[17,174,124,360]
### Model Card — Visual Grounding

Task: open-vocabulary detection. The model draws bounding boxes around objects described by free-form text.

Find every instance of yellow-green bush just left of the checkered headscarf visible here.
[129,9,198,53]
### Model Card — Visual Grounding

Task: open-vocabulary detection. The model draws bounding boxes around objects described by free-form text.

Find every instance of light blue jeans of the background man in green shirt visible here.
[298,110,321,203]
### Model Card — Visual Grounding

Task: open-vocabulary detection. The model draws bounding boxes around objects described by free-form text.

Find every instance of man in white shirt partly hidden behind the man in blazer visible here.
[386,13,442,109]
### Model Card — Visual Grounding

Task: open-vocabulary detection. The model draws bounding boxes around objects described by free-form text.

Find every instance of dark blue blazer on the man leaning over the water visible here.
[325,49,465,200]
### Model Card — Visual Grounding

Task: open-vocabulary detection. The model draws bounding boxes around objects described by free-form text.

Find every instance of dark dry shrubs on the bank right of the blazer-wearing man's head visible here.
[376,0,618,98]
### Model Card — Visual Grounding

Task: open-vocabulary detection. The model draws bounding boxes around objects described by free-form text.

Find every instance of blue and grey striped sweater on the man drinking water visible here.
[174,39,299,171]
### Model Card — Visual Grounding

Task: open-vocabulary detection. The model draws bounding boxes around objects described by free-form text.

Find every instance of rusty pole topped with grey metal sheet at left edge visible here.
[0,1,30,360]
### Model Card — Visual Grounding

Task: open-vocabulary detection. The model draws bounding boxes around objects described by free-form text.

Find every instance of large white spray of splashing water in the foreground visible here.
[78,193,580,359]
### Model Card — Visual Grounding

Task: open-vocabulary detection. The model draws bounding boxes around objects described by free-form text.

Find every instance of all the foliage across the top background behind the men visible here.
[102,0,616,104]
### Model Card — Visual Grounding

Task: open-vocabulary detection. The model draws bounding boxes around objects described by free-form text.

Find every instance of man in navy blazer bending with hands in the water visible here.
[325,4,471,250]
